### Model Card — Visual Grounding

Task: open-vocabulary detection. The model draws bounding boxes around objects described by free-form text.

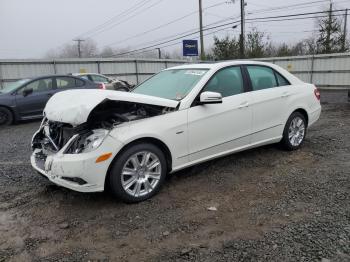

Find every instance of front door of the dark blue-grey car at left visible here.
[16,77,54,119]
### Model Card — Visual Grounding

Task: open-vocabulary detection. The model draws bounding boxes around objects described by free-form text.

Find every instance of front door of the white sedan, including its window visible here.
[188,66,252,161]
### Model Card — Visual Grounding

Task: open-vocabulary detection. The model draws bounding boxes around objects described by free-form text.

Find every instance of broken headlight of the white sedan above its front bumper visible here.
[66,129,109,154]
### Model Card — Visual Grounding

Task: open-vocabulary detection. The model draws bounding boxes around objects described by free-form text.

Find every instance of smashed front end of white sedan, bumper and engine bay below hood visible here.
[31,96,177,192]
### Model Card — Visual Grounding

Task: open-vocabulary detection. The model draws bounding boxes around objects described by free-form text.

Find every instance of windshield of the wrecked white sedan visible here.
[132,69,208,100]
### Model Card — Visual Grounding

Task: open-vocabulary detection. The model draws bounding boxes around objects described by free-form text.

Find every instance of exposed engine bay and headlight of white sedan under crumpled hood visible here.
[32,99,177,155]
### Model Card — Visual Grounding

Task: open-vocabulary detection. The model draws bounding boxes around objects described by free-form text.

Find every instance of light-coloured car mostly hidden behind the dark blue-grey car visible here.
[72,73,134,92]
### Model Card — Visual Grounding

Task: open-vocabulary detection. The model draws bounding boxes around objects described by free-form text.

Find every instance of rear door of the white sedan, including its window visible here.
[246,65,291,144]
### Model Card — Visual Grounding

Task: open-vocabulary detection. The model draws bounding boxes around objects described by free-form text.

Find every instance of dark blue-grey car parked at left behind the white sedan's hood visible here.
[0,75,101,126]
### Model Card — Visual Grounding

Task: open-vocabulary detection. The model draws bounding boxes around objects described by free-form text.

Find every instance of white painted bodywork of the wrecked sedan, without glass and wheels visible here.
[32,61,321,192]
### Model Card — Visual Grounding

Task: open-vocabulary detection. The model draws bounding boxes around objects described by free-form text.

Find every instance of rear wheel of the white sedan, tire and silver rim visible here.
[281,112,307,151]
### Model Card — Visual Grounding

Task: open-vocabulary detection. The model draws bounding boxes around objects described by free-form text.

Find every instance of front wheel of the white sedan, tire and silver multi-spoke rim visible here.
[109,143,167,203]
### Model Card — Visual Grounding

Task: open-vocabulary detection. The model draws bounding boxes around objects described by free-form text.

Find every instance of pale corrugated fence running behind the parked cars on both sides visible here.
[0,53,350,90]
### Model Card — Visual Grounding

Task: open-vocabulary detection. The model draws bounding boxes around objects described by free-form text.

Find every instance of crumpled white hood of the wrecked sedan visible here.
[44,89,179,126]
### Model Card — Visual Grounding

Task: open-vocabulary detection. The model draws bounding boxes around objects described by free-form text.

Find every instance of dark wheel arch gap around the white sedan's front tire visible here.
[104,137,173,188]
